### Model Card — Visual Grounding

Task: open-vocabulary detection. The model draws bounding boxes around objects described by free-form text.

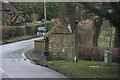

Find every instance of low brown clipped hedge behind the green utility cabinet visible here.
[78,46,120,62]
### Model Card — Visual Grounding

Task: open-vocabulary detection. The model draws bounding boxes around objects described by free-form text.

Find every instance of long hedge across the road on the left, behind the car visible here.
[2,21,53,40]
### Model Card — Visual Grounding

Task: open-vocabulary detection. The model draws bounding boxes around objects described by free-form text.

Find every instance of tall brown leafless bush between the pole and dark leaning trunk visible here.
[78,20,94,45]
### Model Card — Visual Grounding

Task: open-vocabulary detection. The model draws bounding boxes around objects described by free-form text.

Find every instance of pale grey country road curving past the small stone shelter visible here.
[0,38,66,80]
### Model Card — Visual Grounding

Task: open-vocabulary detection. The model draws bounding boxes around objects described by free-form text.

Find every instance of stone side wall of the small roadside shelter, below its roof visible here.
[49,34,73,60]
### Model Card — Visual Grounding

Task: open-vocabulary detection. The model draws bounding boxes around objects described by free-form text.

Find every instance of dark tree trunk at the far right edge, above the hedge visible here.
[114,27,120,48]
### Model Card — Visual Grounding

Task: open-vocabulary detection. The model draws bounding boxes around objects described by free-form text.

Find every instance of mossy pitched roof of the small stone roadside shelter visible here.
[45,24,71,37]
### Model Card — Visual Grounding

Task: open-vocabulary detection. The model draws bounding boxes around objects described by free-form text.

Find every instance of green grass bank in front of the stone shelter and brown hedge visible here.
[40,60,119,78]
